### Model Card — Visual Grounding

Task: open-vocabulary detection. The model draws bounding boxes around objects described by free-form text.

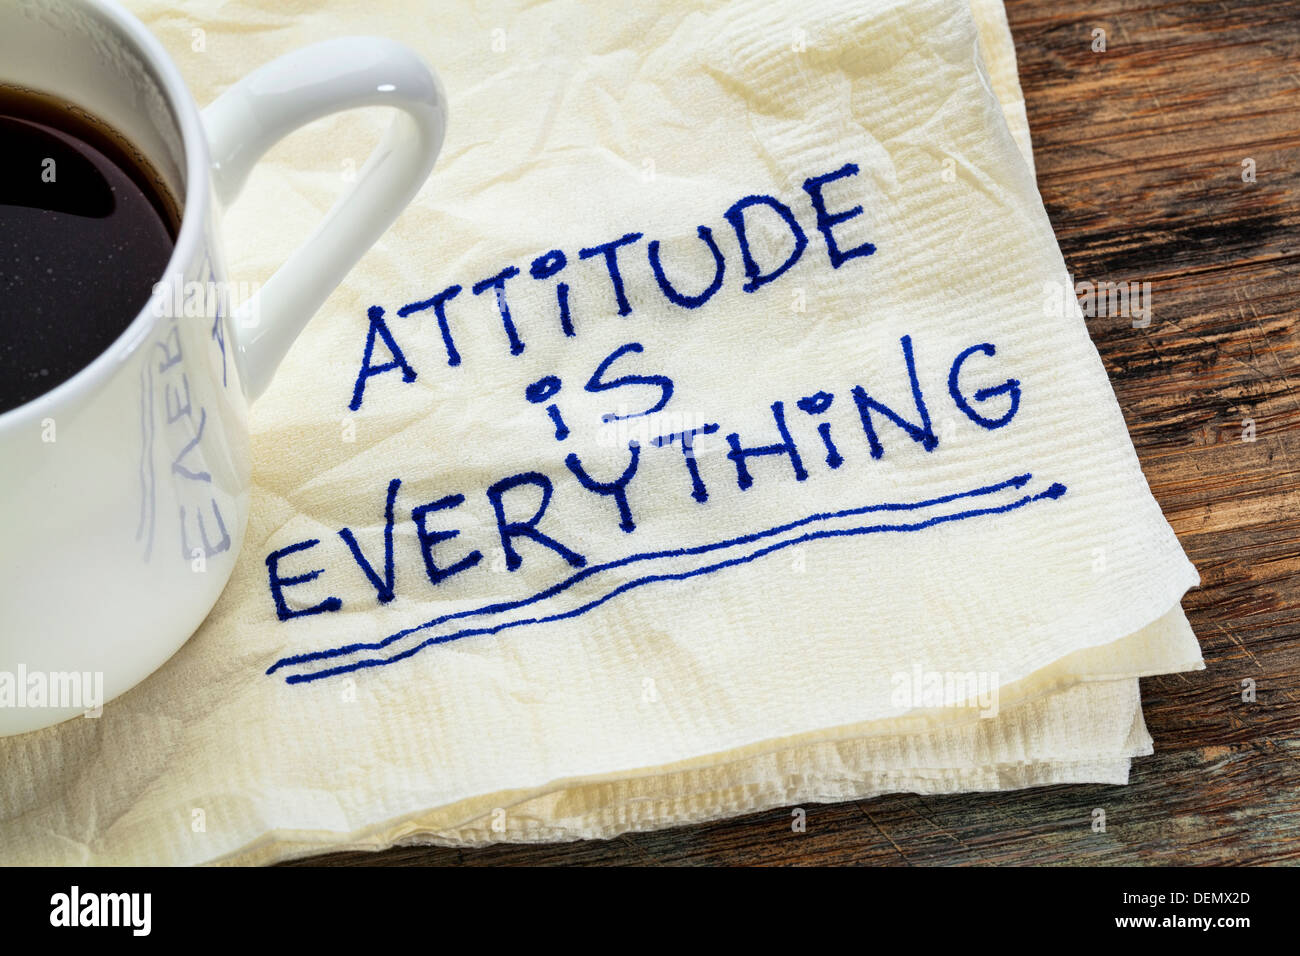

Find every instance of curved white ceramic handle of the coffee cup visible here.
[203,36,447,399]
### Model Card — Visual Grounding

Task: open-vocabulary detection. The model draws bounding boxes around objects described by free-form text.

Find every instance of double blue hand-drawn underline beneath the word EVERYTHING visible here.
[267,473,1066,684]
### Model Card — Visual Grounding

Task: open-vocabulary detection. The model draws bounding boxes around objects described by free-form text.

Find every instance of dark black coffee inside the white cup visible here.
[0,85,179,412]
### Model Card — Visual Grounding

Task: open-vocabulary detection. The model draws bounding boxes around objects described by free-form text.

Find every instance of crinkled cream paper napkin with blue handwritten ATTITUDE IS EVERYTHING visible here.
[0,0,1203,864]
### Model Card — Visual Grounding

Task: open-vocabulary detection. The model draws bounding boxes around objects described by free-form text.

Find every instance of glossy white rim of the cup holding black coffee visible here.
[0,0,209,432]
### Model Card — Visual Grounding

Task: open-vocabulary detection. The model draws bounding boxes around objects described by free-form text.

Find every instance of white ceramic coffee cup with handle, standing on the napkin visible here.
[0,0,446,736]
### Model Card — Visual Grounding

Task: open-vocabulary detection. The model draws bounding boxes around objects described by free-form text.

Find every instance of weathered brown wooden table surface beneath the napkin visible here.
[289,0,1300,865]
